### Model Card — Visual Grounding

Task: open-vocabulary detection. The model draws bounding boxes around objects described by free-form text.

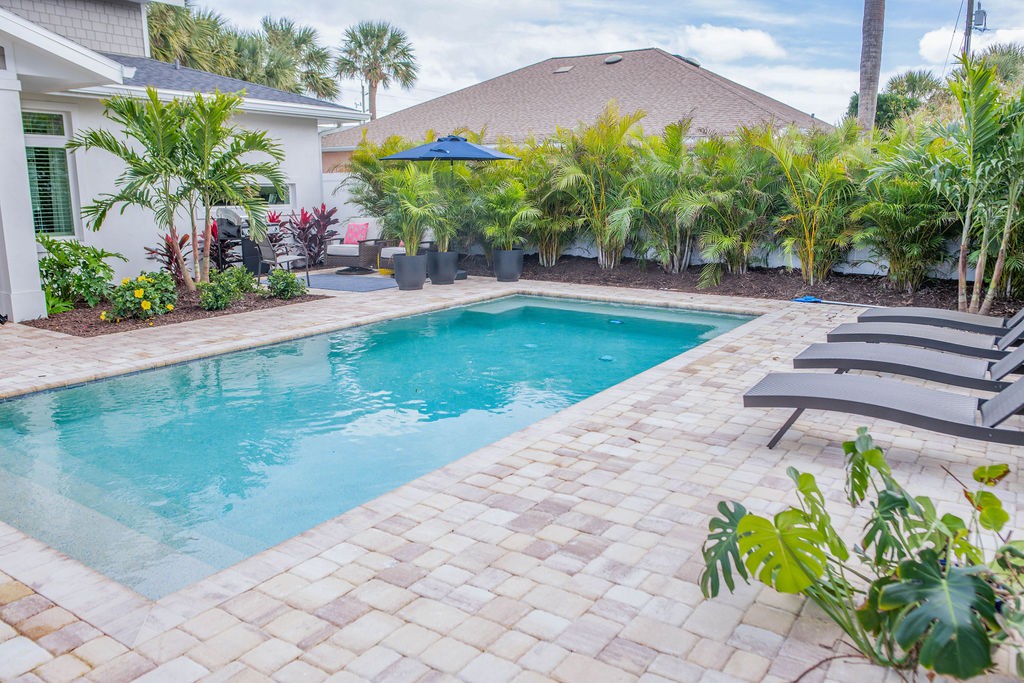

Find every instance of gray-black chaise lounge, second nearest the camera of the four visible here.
[793,342,1024,391]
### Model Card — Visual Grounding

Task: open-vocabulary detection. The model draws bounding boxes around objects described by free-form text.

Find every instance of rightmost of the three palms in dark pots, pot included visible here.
[483,178,541,283]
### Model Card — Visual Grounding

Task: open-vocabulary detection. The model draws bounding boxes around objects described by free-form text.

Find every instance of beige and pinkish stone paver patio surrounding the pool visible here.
[0,279,1024,683]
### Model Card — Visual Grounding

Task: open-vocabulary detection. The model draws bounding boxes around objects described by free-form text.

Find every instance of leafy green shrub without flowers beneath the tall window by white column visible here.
[36,234,128,313]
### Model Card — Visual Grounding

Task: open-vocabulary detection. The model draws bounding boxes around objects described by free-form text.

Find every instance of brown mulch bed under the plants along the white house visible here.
[23,290,328,337]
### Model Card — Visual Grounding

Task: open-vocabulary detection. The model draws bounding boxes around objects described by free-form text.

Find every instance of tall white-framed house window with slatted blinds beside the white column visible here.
[22,112,75,236]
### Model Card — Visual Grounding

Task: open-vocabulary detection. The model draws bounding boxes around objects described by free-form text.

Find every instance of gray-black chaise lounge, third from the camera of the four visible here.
[828,323,1024,360]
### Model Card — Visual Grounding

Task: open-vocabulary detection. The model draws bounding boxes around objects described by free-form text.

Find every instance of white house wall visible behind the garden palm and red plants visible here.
[23,96,323,280]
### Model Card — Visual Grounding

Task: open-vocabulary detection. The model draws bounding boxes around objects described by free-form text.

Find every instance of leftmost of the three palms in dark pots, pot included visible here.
[384,164,443,290]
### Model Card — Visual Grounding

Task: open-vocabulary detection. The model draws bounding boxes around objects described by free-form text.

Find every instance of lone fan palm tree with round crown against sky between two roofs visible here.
[335,22,420,120]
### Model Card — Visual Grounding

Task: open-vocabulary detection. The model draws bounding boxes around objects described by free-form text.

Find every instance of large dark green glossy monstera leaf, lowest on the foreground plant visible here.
[879,550,994,678]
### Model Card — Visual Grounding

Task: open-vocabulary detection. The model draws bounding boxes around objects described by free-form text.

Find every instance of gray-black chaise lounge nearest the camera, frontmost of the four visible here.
[743,373,1024,449]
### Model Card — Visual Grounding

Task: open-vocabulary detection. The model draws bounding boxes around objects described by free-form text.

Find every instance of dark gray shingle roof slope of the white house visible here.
[102,52,359,114]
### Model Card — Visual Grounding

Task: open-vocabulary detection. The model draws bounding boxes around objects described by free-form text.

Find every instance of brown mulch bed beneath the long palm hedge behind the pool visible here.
[461,256,1024,315]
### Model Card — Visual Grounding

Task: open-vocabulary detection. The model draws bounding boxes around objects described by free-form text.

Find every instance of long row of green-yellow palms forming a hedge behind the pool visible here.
[348,53,1024,312]
